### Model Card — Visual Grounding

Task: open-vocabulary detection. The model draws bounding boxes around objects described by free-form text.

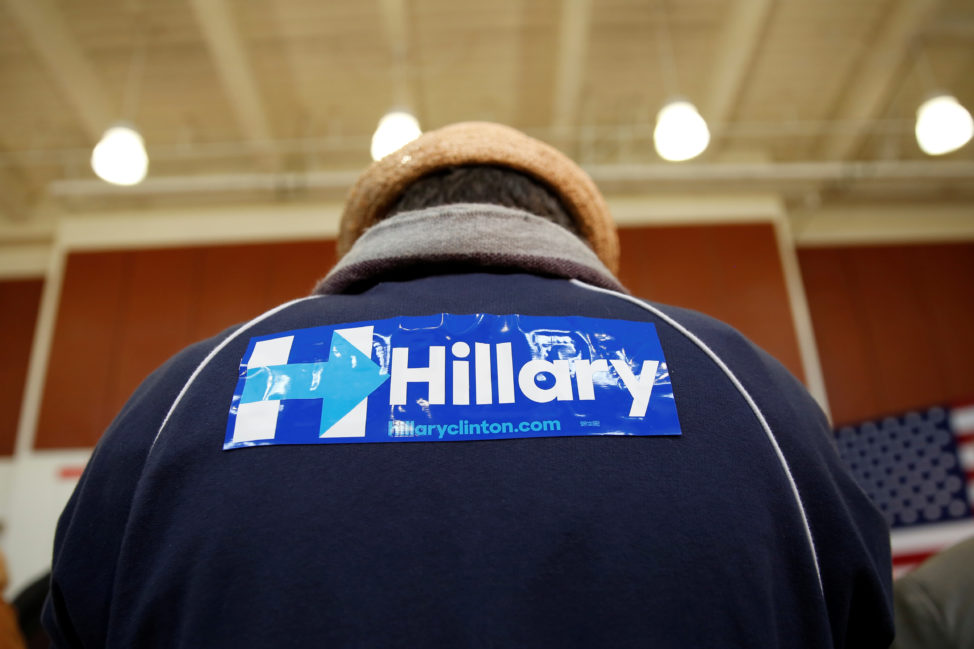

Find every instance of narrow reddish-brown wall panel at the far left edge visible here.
[0,279,44,455]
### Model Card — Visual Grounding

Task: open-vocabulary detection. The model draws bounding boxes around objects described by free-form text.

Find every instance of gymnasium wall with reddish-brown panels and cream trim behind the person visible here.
[0,201,974,593]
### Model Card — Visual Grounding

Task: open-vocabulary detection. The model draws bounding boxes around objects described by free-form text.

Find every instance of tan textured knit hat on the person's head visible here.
[338,122,619,273]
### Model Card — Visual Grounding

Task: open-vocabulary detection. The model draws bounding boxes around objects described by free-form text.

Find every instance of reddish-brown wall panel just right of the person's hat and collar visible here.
[619,224,805,380]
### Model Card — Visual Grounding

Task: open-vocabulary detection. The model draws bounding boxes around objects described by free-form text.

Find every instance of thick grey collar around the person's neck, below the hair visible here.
[314,203,627,295]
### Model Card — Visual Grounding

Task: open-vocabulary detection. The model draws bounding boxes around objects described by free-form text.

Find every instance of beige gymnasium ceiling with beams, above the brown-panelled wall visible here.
[0,0,974,224]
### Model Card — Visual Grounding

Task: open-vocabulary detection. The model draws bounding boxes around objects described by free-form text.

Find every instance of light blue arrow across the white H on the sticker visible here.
[240,331,389,437]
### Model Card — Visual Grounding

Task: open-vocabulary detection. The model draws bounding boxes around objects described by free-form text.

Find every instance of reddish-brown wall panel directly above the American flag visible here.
[799,244,974,424]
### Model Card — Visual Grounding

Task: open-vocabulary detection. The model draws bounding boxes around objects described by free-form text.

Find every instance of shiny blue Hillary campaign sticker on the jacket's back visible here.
[223,313,680,449]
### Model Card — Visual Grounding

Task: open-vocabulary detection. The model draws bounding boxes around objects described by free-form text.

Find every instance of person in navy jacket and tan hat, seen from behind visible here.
[46,125,891,647]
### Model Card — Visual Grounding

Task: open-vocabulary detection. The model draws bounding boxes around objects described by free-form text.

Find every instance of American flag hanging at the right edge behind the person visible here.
[835,403,974,577]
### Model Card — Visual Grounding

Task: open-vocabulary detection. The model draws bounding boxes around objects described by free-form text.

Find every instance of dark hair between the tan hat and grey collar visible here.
[382,165,579,235]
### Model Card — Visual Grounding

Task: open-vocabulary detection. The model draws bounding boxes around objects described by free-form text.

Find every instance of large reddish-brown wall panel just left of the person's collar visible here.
[35,241,335,448]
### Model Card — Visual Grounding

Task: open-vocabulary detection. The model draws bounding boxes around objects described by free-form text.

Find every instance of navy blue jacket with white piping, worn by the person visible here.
[45,210,892,649]
